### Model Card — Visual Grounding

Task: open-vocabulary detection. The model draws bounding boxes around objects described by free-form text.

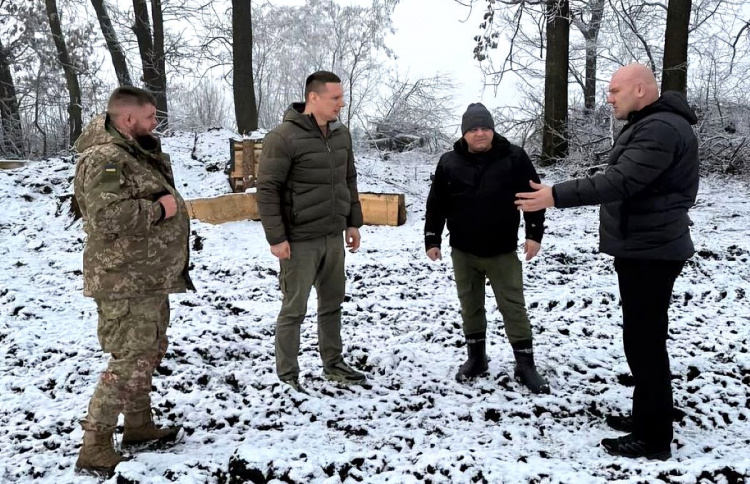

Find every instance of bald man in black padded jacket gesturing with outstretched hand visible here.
[516,64,698,460]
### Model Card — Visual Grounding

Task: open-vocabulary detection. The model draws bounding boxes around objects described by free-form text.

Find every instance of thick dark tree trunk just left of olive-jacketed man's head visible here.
[232,0,258,134]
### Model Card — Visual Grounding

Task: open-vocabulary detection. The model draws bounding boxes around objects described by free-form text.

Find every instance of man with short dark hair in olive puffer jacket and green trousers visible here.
[258,71,367,392]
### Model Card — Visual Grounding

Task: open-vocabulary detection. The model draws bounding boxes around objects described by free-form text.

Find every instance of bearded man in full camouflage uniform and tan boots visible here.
[75,87,193,474]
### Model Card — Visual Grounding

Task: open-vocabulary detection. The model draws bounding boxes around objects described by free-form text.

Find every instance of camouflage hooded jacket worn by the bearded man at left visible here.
[75,115,194,299]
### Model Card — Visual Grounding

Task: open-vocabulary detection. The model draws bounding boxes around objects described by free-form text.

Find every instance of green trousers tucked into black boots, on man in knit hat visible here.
[451,248,532,344]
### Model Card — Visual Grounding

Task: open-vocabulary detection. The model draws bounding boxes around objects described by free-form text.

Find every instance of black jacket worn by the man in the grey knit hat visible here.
[425,133,544,257]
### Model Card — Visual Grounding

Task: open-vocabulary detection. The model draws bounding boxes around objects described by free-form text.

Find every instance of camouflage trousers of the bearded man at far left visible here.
[81,295,169,432]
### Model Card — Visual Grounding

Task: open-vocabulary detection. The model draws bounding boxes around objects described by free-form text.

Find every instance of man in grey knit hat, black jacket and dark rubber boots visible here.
[425,103,550,393]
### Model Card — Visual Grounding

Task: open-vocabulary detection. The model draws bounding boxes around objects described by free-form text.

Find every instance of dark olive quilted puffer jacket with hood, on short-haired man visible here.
[258,103,362,245]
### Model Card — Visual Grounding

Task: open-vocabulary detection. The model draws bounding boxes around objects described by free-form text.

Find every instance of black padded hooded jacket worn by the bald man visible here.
[553,91,698,260]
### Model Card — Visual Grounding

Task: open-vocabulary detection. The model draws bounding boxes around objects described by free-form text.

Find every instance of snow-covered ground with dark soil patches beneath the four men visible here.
[0,131,750,483]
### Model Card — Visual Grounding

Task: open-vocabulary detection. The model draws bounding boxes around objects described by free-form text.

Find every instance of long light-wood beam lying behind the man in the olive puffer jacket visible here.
[191,193,406,226]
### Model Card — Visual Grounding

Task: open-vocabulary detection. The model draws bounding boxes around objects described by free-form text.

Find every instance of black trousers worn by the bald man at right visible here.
[615,257,685,446]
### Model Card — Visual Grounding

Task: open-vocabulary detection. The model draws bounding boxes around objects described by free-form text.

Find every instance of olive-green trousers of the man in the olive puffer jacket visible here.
[276,234,346,380]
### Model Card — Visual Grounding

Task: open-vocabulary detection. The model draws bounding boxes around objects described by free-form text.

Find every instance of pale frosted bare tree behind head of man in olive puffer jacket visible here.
[201,0,396,127]
